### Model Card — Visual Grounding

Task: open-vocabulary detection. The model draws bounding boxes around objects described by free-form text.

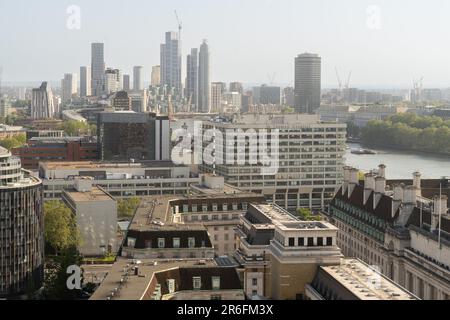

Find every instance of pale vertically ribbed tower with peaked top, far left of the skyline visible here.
[31,82,55,119]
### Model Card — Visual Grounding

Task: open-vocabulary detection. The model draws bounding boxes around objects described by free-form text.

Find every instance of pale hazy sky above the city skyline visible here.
[0,0,450,88]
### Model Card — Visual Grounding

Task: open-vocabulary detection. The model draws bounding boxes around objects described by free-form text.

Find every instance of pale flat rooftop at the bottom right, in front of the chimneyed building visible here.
[320,259,417,300]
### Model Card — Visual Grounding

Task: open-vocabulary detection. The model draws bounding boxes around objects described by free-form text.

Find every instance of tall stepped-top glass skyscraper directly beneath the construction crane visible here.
[161,32,183,95]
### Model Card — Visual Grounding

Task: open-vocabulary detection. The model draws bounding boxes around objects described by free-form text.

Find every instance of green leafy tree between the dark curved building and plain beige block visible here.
[44,201,81,255]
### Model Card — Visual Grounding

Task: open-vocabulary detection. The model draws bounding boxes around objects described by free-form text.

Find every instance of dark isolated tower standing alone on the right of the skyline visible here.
[295,53,322,113]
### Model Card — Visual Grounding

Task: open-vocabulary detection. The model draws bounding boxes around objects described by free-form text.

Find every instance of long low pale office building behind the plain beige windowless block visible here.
[39,161,199,200]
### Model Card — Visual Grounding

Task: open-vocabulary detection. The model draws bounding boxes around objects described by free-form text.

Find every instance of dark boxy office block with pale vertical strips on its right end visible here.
[97,111,170,161]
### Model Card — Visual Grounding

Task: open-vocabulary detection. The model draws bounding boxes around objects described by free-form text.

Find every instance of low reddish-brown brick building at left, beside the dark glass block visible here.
[12,137,99,170]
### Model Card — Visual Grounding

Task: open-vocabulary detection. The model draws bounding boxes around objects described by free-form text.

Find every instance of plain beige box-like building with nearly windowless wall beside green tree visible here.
[62,177,118,257]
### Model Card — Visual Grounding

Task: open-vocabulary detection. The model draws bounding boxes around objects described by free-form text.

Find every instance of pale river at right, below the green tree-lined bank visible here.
[346,143,450,179]
